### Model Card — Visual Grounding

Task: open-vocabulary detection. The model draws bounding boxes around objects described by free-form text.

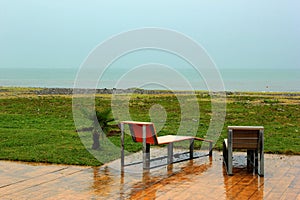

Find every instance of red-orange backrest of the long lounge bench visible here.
[128,123,158,144]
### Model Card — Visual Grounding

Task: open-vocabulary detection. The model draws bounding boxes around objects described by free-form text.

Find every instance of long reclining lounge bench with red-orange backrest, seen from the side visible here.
[120,121,213,169]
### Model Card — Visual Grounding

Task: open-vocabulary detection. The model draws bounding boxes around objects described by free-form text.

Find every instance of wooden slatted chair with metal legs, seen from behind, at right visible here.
[223,126,264,176]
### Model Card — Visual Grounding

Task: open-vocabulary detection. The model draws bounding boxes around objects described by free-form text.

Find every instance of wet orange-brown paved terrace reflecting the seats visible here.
[0,148,300,199]
